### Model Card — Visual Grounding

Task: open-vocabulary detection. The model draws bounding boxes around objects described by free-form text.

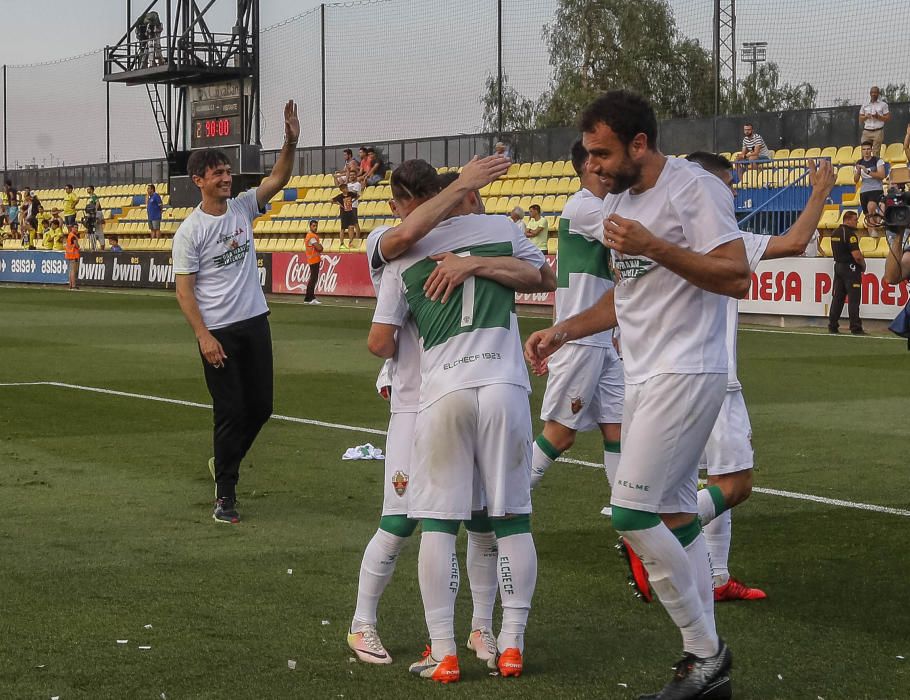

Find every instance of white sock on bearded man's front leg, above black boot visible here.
[620,523,719,658]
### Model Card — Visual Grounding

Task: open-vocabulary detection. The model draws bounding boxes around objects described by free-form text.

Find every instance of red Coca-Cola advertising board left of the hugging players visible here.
[272,253,375,297]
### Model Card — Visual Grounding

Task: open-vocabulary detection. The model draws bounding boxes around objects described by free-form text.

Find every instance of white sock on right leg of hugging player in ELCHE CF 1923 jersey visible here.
[497,532,537,652]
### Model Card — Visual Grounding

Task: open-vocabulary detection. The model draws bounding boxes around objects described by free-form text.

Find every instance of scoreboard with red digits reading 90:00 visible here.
[190,80,249,149]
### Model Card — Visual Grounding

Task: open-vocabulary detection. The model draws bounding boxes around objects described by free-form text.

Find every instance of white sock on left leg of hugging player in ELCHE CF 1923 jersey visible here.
[417,532,459,661]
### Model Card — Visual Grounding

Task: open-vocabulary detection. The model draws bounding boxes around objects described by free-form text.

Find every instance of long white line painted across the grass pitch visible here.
[0,382,910,517]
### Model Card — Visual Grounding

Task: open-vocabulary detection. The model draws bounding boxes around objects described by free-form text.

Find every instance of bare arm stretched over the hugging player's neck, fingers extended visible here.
[379,156,511,260]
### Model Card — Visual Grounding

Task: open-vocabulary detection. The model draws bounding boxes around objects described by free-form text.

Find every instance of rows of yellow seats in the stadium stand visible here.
[3,143,907,257]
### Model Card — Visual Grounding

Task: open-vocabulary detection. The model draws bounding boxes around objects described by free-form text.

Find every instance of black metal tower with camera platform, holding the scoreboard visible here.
[104,0,262,206]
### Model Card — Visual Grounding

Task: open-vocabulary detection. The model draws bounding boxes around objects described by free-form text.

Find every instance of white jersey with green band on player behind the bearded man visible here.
[556,189,613,347]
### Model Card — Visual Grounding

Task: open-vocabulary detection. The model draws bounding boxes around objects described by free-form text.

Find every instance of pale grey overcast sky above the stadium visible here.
[0,0,910,167]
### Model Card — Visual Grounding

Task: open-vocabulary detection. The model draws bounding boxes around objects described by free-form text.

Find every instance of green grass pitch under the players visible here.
[0,287,910,700]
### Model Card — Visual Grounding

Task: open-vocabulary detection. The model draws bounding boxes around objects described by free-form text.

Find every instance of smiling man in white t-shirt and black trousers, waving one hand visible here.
[173,100,300,523]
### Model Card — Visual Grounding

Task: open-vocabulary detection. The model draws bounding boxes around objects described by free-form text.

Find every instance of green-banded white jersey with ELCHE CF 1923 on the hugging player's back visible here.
[373,214,546,410]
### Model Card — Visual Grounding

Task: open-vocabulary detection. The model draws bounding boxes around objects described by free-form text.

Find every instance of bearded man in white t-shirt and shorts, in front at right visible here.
[525,91,750,699]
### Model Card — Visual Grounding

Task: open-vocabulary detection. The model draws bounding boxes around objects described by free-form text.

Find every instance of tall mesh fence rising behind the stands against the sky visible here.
[0,0,910,175]
